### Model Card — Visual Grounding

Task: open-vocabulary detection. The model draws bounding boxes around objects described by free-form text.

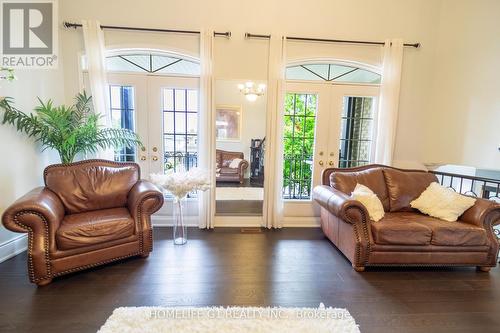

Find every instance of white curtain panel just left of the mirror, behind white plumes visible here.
[198,29,215,229]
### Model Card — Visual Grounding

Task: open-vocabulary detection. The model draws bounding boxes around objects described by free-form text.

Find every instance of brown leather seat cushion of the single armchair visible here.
[56,208,134,250]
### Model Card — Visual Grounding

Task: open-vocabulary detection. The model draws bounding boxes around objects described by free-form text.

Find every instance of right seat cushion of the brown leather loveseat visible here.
[425,218,487,246]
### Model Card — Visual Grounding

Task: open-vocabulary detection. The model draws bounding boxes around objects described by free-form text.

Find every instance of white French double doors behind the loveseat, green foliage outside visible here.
[283,82,379,219]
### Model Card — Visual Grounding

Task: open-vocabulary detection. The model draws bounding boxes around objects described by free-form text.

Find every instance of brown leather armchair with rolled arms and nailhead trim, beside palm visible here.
[2,160,163,285]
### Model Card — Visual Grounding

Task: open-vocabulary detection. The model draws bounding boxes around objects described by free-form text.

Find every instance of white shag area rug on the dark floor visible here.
[98,304,360,333]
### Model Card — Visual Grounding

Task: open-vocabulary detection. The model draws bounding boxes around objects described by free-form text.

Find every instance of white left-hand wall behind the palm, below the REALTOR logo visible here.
[0,70,64,260]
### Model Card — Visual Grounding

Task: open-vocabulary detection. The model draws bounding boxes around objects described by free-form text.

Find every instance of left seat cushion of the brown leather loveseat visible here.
[371,212,432,245]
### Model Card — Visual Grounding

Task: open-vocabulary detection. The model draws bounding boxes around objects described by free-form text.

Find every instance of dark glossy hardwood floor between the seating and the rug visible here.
[0,228,500,333]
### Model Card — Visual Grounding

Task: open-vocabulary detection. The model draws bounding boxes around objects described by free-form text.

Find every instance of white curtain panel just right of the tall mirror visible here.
[263,35,286,228]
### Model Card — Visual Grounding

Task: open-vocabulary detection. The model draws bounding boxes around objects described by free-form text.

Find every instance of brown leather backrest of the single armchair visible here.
[44,160,140,214]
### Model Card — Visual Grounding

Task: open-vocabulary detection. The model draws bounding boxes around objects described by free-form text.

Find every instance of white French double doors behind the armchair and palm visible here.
[108,74,199,178]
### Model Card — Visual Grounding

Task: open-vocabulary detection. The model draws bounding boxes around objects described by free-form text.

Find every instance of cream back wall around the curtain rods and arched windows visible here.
[60,0,441,169]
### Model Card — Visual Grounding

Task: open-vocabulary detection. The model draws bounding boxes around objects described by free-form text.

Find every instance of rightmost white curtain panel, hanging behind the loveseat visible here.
[375,39,403,165]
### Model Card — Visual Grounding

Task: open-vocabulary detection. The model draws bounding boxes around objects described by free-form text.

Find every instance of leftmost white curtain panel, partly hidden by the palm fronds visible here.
[82,20,113,159]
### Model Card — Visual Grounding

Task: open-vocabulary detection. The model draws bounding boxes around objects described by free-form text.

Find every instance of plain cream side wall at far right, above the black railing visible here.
[425,0,500,169]
